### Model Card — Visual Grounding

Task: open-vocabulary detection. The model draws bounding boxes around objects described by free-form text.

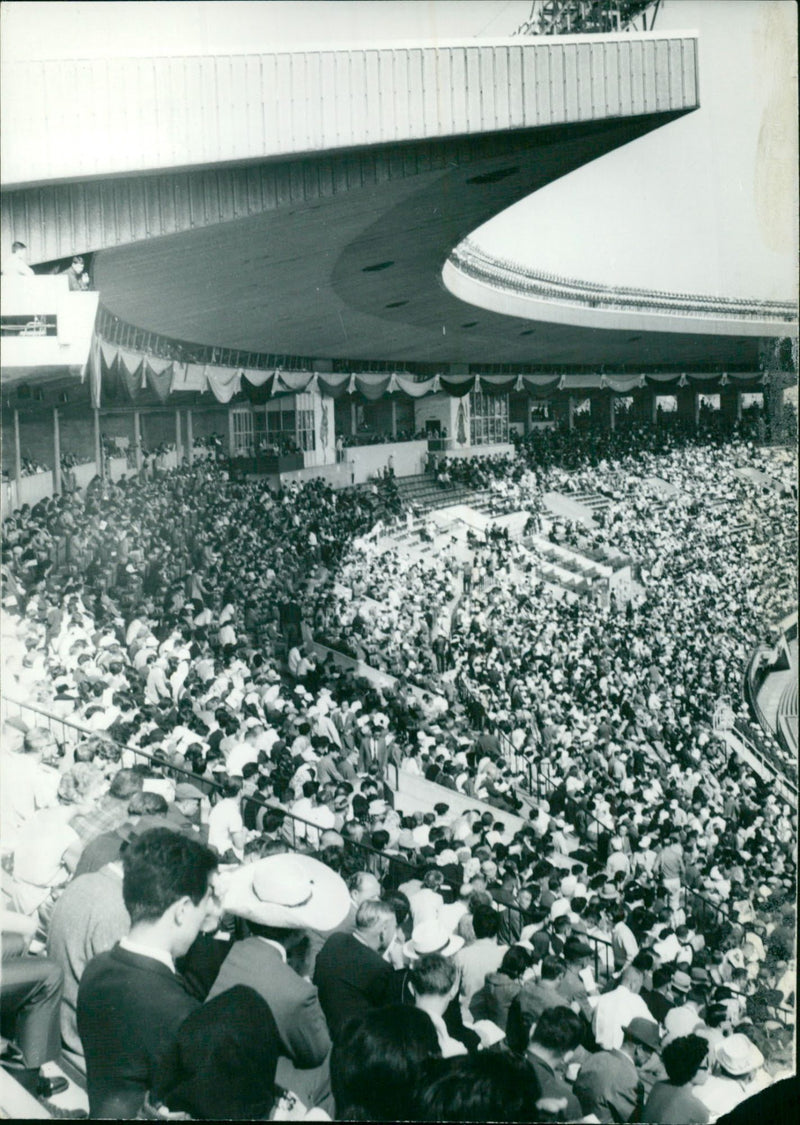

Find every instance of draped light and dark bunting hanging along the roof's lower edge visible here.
[81,336,768,407]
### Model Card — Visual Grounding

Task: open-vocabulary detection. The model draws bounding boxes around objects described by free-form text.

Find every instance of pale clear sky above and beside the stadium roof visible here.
[0,0,798,299]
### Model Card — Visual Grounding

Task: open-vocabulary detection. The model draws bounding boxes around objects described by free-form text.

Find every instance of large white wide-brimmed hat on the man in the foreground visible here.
[222,854,350,930]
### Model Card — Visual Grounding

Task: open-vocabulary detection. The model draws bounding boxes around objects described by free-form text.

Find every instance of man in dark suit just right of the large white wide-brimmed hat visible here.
[314,899,397,1043]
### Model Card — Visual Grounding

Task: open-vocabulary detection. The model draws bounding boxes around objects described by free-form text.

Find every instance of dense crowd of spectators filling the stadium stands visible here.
[0,420,797,1122]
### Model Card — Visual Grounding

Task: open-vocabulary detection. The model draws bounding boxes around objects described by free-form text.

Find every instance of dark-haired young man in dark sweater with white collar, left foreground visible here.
[78,828,217,1118]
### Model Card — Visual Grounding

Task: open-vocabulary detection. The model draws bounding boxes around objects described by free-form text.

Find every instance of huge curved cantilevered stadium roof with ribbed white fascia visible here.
[2,34,785,369]
